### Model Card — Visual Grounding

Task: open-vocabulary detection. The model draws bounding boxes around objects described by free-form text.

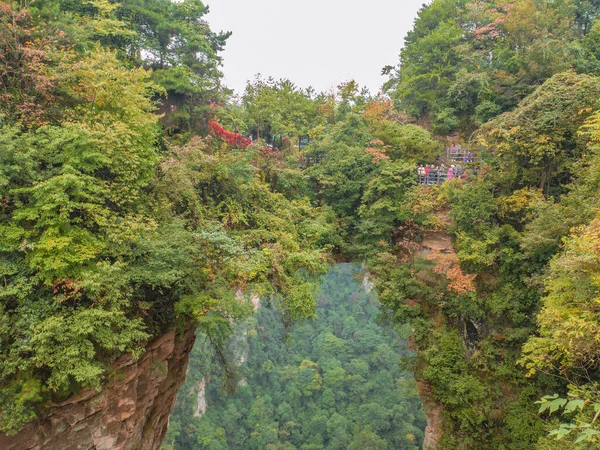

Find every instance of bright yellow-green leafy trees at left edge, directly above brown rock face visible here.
[0,44,165,430]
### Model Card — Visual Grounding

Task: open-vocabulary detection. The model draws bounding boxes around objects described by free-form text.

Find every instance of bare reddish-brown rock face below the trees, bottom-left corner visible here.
[0,329,196,450]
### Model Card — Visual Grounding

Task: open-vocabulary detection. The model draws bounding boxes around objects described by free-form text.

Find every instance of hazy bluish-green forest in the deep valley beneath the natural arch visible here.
[163,264,425,450]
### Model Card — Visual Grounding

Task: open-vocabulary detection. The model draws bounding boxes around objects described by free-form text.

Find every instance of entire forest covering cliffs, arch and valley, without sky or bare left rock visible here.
[0,0,600,450]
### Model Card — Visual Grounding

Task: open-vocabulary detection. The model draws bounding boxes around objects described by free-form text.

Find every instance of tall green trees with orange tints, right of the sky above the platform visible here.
[385,0,599,135]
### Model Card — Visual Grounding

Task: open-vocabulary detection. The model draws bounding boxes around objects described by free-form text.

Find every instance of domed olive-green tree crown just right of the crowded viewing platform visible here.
[481,72,600,193]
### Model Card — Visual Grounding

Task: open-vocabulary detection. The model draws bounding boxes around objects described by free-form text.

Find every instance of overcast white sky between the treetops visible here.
[205,0,425,94]
